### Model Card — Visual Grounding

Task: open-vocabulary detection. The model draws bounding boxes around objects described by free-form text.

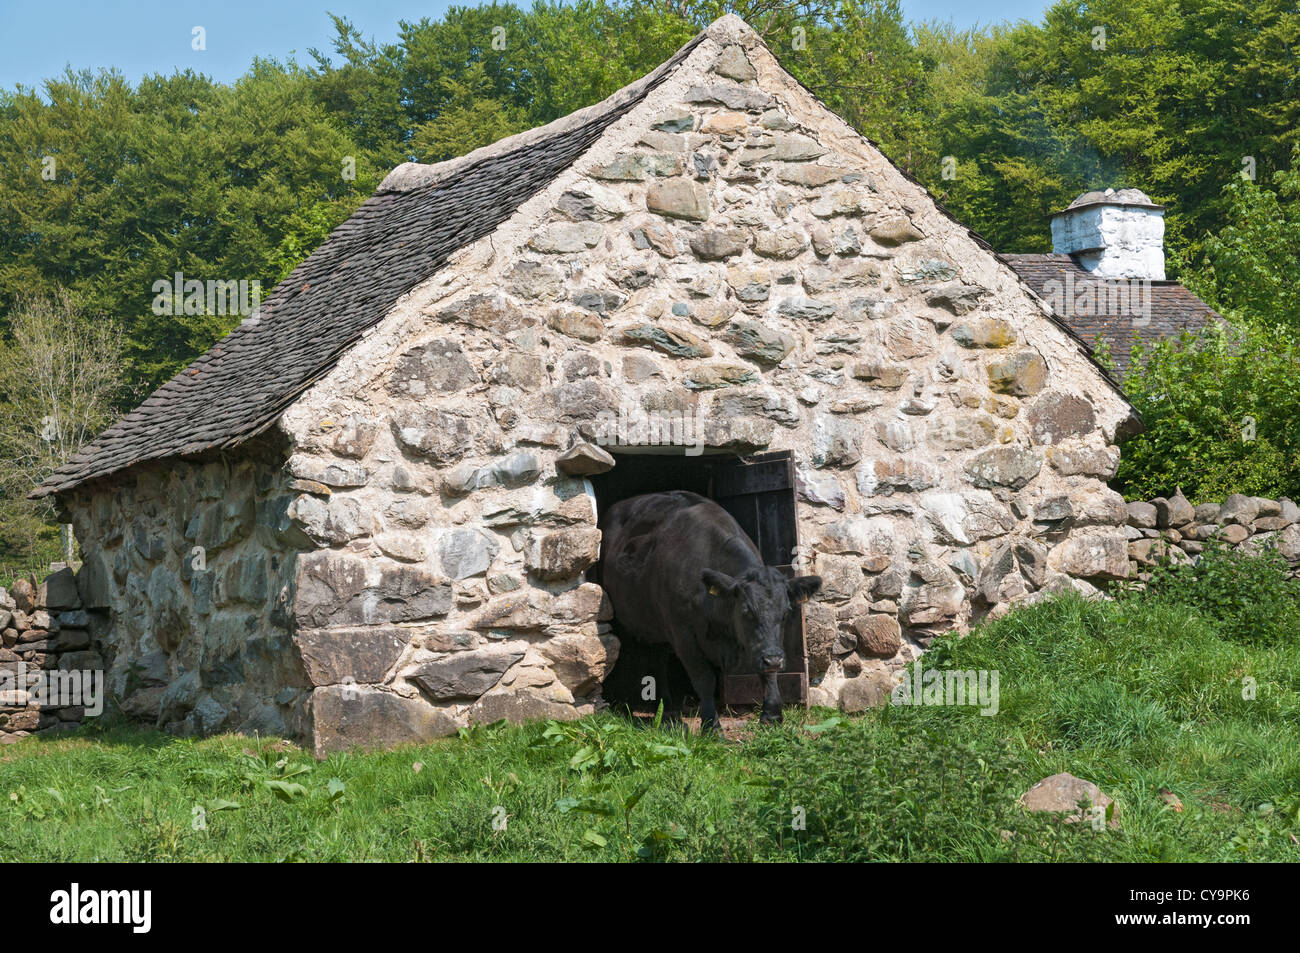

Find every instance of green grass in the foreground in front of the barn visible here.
[0,598,1300,861]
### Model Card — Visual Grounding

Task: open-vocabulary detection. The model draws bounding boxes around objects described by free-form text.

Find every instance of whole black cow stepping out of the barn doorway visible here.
[601,490,822,731]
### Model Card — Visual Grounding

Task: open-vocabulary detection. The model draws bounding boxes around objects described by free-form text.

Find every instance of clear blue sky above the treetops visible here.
[0,0,1049,88]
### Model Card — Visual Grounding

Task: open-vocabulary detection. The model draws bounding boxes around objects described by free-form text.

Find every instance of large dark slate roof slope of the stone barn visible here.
[31,33,705,498]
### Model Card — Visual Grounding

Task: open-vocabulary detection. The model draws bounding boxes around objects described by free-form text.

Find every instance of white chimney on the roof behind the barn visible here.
[1052,189,1165,281]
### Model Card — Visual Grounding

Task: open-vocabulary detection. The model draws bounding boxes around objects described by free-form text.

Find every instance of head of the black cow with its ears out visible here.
[703,566,822,675]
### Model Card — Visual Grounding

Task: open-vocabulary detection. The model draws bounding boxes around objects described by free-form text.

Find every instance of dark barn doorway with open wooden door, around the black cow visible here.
[589,450,807,714]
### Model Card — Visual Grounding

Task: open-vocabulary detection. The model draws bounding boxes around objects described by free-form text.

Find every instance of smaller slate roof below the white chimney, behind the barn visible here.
[1001,254,1223,373]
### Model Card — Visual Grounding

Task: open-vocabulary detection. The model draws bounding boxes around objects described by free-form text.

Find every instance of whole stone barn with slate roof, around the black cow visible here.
[39,16,1136,753]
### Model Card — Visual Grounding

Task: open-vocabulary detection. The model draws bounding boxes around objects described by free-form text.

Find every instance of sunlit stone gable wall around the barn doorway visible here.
[282,26,1130,750]
